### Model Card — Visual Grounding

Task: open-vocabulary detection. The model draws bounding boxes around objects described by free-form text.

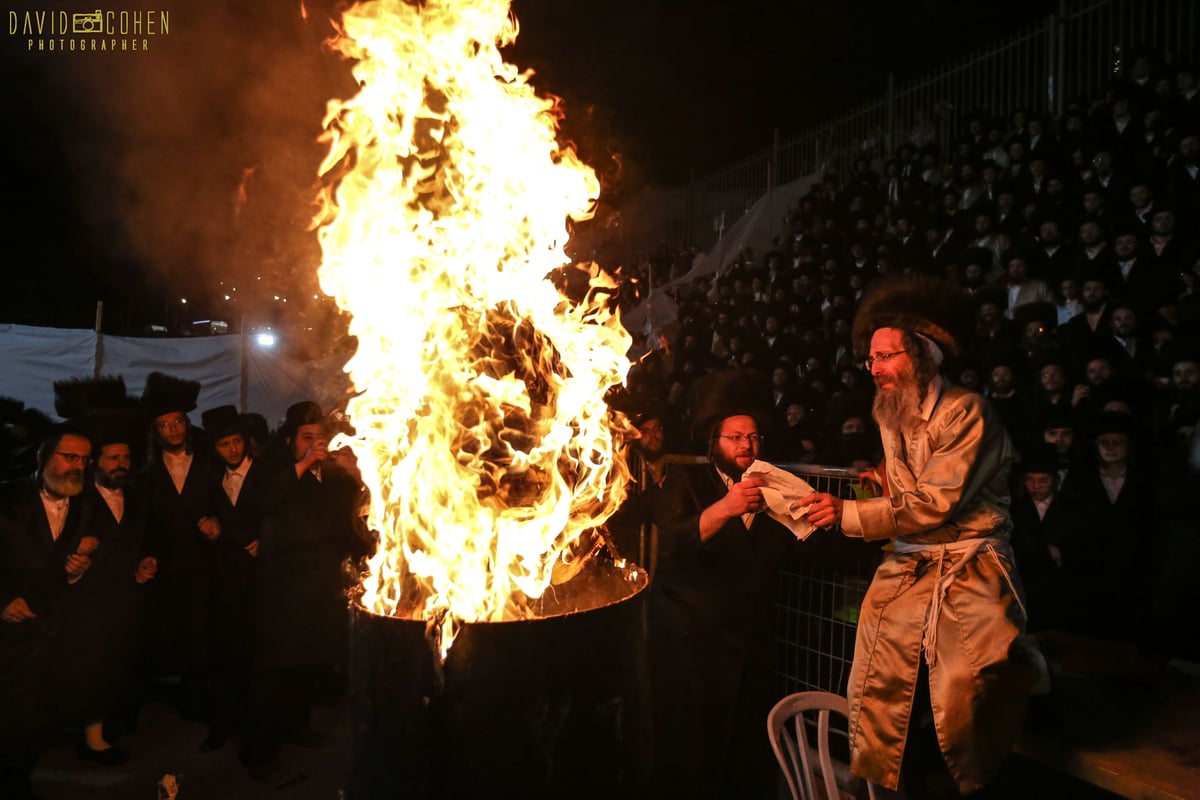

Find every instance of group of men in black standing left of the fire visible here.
[0,372,373,798]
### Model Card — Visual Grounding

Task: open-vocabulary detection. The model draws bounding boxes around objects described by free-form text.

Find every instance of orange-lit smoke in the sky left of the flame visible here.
[5,0,354,333]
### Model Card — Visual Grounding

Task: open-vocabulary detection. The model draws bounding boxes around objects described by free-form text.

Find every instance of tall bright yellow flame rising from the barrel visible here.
[318,0,630,656]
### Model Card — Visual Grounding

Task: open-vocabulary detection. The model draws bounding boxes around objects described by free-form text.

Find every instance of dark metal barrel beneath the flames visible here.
[350,560,649,800]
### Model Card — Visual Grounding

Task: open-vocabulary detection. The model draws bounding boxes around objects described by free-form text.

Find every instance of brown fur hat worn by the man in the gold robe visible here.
[853,275,970,357]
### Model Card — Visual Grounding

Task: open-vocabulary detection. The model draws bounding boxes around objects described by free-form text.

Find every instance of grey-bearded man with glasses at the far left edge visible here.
[0,426,97,799]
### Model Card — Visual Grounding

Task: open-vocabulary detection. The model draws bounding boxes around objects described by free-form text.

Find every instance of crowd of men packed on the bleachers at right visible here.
[625,58,1200,660]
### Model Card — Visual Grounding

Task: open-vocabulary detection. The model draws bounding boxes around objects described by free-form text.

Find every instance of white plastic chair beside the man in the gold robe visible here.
[767,692,875,800]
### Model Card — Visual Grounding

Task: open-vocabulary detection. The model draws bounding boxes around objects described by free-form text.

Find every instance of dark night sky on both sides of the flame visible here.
[0,0,1049,333]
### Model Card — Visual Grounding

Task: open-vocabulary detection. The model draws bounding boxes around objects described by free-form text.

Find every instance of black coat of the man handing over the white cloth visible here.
[649,464,796,798]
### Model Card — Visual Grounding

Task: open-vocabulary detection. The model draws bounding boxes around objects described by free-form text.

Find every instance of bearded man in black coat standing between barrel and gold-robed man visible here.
[648,371,796,798]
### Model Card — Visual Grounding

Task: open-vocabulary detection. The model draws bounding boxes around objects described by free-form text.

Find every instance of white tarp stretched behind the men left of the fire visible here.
[0,325,348,427]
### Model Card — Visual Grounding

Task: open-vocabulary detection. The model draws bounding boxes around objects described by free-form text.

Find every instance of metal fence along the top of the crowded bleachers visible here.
[660,0,1200,251]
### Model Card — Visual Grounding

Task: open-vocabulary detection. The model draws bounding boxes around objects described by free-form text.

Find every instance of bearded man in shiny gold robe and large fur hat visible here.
[798,279,1034,798]
